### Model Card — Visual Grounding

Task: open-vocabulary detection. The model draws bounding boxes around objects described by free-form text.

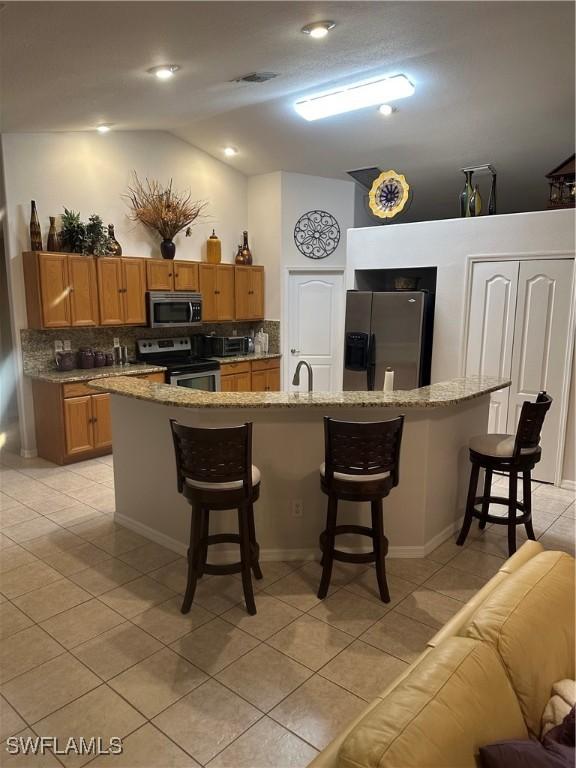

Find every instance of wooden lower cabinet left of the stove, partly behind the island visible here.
[32,373,164,464]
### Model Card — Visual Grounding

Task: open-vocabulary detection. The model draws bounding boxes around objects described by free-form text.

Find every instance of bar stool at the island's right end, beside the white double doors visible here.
[456,392,552,555]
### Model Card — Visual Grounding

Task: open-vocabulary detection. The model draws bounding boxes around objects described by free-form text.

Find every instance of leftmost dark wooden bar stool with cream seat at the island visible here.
[170,419,262,615]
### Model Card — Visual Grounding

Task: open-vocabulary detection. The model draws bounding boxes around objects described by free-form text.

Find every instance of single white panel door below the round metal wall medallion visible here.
[287,272,344,392]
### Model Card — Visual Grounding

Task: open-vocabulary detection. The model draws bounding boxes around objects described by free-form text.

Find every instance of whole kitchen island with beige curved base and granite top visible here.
[89,377,510,561]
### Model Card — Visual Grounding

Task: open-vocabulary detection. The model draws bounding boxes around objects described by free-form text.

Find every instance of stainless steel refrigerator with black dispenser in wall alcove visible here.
[344,291,434,391]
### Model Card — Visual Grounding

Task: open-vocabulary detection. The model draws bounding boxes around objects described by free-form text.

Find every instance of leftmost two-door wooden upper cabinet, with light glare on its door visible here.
[23,251,99,328]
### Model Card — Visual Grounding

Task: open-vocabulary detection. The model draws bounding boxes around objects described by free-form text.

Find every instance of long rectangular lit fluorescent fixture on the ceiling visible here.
[294,75,414,120]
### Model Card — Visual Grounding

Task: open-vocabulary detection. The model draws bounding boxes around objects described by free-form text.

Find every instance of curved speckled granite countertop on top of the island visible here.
[90,376,510,409]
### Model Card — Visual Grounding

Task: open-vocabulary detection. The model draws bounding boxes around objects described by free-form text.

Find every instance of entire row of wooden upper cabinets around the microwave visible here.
[23,251,264,329]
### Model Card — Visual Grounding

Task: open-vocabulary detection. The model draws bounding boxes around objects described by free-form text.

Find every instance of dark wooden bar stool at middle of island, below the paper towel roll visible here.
[318,416,404,603]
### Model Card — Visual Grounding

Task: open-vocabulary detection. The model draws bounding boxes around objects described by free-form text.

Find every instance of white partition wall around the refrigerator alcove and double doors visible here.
[346,210,575,479]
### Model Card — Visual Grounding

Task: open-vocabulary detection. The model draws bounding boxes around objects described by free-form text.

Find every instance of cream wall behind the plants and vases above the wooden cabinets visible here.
[2,131,248,450]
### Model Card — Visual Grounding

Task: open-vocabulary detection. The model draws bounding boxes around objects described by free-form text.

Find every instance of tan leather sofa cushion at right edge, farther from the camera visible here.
[462,552,574,738]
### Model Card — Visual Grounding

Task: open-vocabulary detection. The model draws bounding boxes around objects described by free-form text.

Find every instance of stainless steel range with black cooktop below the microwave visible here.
[136,338,220,392]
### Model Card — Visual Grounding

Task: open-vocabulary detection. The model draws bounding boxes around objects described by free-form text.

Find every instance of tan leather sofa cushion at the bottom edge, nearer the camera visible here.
[338,637,527,768]
